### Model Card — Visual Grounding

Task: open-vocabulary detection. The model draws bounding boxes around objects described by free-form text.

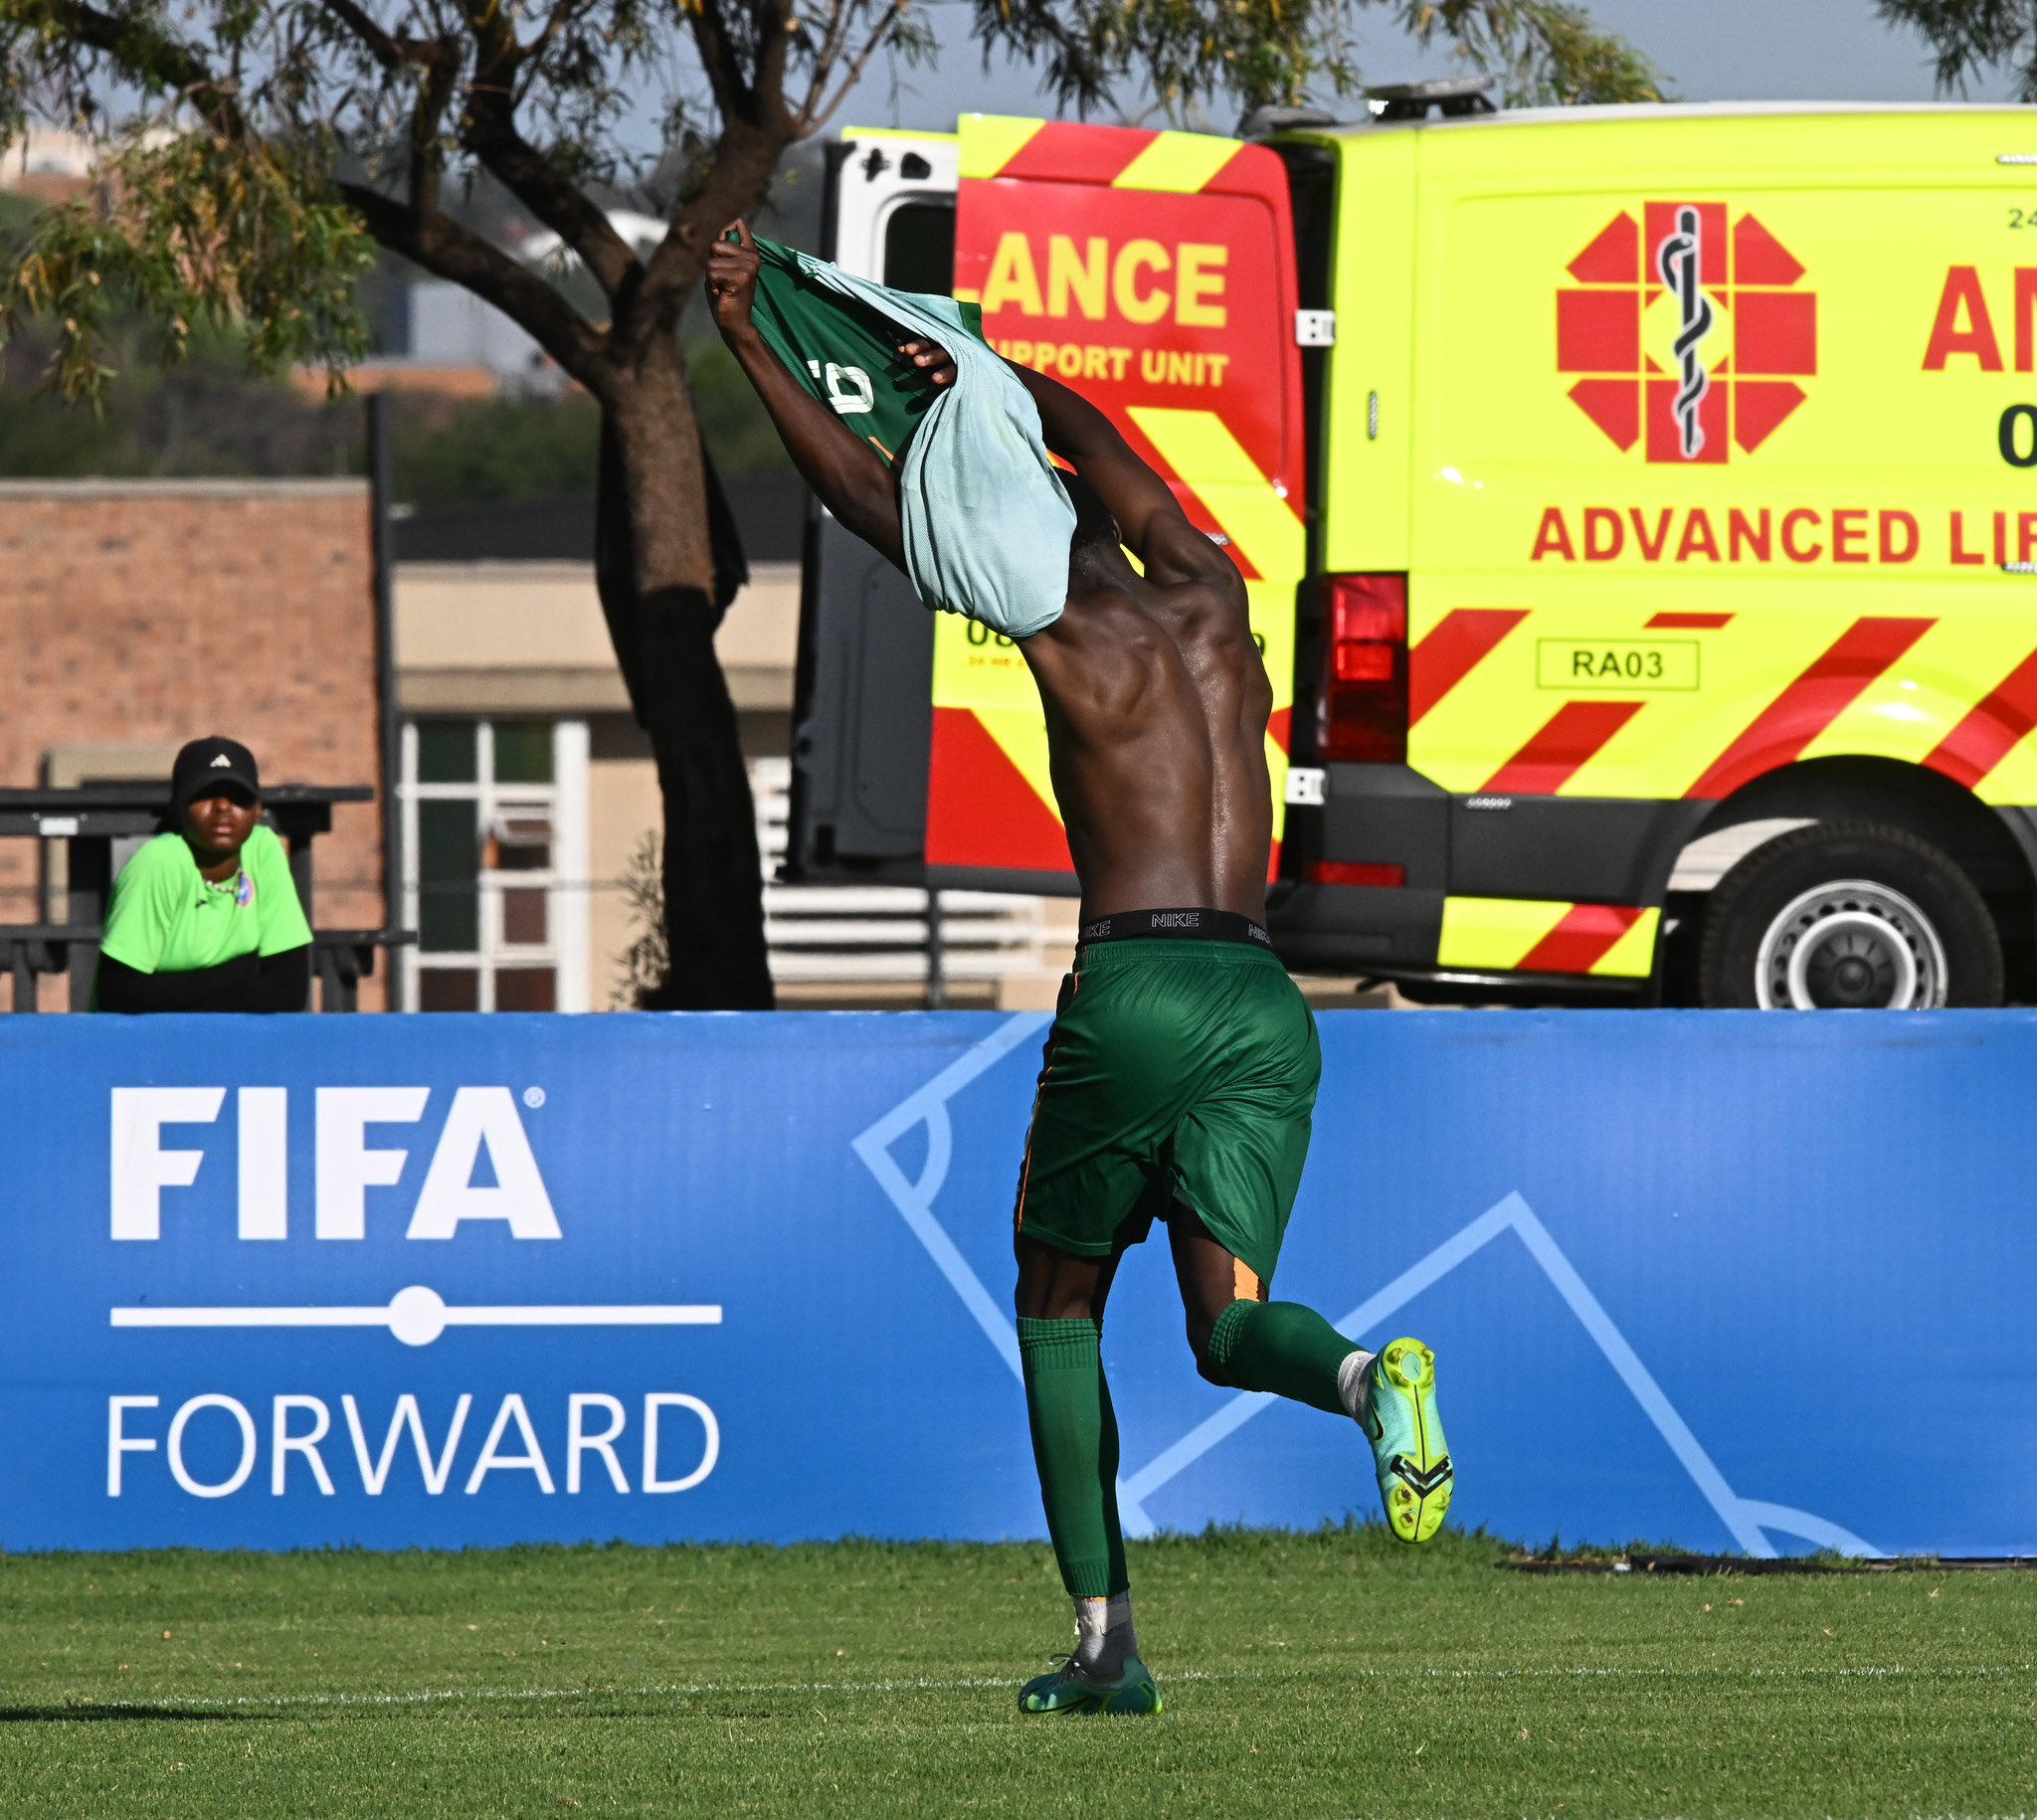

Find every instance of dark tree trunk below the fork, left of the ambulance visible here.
[603,336,772,1011]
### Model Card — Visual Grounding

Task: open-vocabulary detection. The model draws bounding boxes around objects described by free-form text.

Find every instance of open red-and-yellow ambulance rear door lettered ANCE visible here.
[925,114,1306,894]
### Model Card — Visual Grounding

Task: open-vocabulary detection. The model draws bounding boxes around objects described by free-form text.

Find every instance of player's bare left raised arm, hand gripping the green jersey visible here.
[707,222,904,568]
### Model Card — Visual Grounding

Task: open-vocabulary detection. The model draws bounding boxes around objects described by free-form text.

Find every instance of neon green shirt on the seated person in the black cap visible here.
[99,824,311,973]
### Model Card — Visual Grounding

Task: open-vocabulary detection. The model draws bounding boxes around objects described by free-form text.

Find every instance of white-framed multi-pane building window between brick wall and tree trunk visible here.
[404,719,589,1011]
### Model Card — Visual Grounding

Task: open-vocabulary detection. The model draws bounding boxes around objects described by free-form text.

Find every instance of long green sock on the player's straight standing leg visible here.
[1018,1315,1131,1598]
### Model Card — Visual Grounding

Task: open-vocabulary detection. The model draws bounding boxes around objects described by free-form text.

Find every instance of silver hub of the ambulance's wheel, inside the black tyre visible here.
[1754,879,1947,1011]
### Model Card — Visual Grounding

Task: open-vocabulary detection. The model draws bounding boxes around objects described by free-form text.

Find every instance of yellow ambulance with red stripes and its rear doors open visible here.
[789,84,2037,1009]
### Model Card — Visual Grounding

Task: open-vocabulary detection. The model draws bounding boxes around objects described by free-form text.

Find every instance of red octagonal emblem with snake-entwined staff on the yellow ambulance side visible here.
[1557,202,1817,464]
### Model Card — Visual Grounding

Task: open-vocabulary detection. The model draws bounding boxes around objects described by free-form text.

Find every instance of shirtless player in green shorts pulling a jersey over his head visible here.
[707,224,1454,1715]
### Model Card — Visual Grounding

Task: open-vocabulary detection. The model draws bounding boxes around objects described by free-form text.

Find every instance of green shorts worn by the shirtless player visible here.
[1015,937,1322,1283]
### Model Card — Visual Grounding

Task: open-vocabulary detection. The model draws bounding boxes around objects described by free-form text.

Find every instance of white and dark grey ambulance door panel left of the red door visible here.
[784,128,956,883]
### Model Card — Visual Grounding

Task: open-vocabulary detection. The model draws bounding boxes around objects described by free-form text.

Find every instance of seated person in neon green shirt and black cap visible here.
[93,735,311,1011]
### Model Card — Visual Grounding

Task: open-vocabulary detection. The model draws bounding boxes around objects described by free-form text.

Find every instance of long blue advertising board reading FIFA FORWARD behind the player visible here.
[0,1011,2037,1555]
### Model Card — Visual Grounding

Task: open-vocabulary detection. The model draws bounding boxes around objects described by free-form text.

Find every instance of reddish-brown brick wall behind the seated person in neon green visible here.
[0,480,385,1009]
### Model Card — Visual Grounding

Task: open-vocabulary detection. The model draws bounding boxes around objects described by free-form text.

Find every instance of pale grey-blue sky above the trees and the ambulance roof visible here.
[835,0,2012,130]
